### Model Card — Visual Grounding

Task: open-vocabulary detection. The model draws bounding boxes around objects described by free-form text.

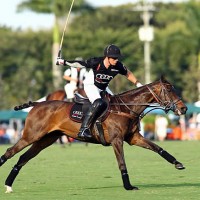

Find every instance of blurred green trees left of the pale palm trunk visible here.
[0,28,53,108]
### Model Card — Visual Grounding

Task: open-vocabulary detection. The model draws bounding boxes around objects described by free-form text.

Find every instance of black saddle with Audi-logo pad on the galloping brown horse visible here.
[70,93,109,146]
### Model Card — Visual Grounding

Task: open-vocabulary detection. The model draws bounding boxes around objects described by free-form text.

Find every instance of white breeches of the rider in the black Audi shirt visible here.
[84,84,113,103]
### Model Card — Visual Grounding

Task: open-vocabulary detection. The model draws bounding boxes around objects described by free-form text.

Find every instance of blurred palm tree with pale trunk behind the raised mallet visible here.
[18,0,92,89]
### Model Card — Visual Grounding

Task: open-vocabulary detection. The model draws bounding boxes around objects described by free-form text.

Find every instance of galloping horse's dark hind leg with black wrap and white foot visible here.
[5,132,62,193]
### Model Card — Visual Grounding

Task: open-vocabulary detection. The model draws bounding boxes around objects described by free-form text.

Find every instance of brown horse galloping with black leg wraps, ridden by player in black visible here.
[0,77,187,193]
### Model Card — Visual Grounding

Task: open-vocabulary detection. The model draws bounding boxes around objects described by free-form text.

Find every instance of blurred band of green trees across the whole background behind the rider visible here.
[0,1,200,109]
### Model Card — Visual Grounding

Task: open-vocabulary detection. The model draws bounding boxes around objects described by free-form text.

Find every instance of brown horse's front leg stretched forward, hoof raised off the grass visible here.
[129,133,185,170]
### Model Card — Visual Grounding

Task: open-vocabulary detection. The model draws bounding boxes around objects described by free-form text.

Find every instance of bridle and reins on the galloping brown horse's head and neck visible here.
[110,80,181,118]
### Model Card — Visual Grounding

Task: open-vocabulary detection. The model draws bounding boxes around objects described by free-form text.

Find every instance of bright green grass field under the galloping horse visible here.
[0,141,200,200]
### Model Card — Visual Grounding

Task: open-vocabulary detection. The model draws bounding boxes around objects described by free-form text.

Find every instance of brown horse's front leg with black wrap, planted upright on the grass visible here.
[111,138,138,190]
